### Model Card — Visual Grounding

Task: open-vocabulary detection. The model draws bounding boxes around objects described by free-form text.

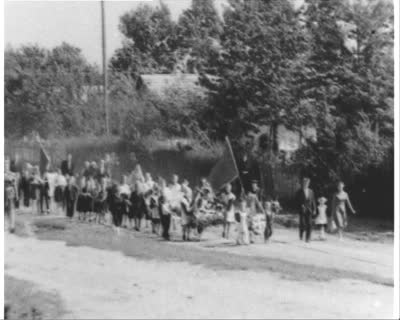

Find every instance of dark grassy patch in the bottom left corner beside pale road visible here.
[4,276,65,320]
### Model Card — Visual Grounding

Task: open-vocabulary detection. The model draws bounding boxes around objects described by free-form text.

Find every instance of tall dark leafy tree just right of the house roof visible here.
[204,1,301,141]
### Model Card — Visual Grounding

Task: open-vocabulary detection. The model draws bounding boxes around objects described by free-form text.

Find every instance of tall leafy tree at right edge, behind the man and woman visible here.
[294,0,393,195]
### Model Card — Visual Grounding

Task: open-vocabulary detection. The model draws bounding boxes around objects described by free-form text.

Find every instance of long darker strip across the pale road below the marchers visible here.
[26,218,394,286]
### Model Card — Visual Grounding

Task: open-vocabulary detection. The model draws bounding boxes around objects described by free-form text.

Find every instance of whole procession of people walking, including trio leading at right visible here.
[5,154,355,244]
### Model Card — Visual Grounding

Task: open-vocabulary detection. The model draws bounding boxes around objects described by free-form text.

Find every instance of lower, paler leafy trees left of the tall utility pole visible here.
[5,43,99,136]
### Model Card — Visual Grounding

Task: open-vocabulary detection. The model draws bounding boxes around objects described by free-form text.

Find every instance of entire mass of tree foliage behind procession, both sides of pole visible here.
[5,0,394,210]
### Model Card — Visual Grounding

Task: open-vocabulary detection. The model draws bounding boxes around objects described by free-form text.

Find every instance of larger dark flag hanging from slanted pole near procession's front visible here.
[208,137,239,190]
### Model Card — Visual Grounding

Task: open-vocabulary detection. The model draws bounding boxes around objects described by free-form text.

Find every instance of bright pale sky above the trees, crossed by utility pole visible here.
[4,0,200,66]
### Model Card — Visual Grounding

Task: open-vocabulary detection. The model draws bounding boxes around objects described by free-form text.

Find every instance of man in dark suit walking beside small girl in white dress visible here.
[296,177,317,242]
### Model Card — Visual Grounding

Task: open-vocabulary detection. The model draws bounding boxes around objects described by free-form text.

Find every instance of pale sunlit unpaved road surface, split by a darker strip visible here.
[5,226,393,319]
